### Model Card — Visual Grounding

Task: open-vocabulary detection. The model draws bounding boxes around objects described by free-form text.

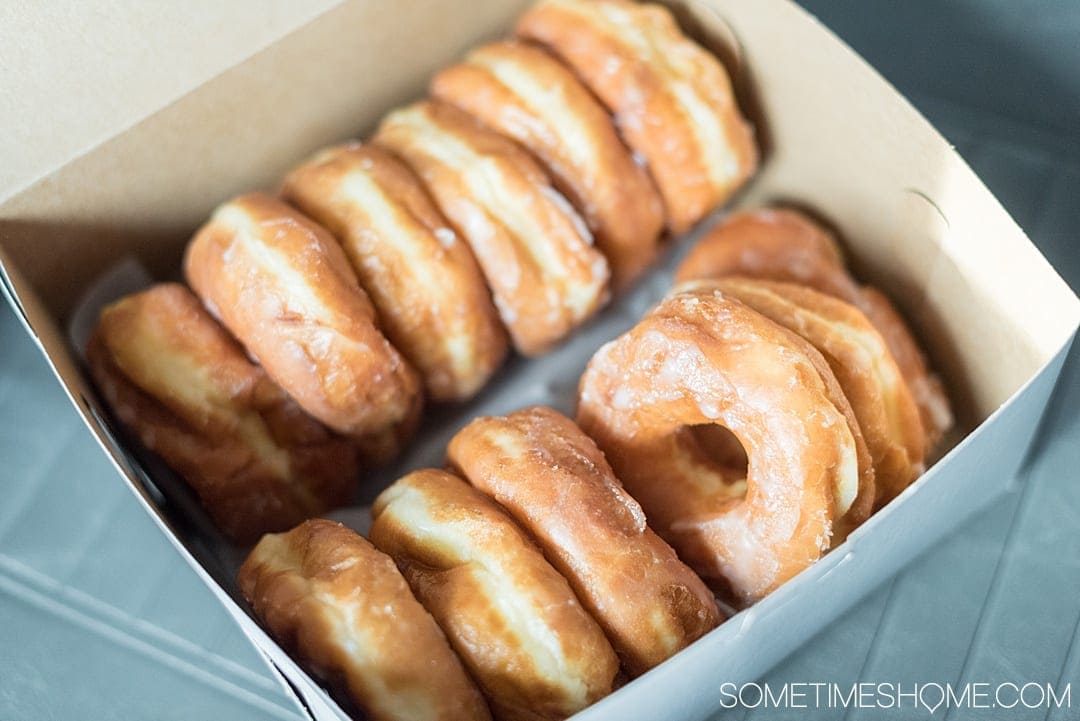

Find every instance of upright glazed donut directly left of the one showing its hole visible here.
[447,407,721,676]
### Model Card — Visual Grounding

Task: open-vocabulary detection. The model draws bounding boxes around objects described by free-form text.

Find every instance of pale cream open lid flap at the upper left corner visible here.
[0,0,340,199]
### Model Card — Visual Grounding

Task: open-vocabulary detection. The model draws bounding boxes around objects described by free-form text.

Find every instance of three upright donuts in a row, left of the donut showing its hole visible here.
[239,407,723,721]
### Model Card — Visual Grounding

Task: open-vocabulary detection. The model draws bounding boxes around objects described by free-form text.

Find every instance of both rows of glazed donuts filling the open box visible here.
[87,0,951,721]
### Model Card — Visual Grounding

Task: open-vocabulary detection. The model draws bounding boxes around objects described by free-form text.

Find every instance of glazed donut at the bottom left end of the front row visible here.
[238,518,491,721]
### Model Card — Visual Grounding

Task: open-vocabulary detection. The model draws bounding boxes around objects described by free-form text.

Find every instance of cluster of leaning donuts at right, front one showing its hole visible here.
[577,208,953,604]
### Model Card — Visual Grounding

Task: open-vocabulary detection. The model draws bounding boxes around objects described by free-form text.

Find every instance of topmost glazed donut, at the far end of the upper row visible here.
[517,0,757,233]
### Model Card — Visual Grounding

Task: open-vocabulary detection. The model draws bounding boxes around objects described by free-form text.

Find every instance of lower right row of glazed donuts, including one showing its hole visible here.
[240,209,951,719]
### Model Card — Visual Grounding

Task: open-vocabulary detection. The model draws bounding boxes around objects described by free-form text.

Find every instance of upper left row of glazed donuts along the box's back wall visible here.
[87,0,757,542]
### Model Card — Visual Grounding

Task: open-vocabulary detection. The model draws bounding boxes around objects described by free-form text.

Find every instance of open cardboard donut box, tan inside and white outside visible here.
[0,0,1080,720]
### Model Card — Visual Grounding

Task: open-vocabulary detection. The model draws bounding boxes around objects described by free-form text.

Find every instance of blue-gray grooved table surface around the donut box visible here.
[0,0,1080,720]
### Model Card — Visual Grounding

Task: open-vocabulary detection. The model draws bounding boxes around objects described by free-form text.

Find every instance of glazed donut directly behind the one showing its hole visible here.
[699,276,926,507]
